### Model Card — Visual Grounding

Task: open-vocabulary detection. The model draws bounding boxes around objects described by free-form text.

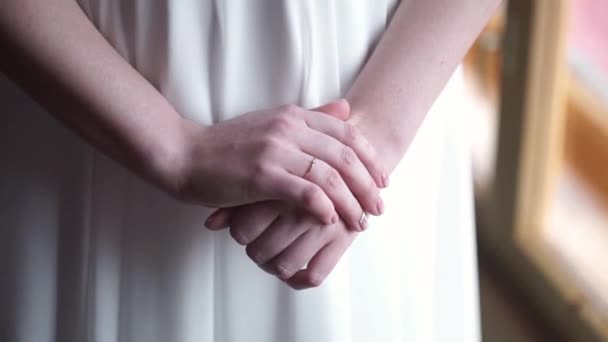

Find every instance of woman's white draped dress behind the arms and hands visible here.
[0,0,479,342]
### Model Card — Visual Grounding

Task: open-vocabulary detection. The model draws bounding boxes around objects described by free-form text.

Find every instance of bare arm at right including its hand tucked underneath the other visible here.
[207,0,500,289]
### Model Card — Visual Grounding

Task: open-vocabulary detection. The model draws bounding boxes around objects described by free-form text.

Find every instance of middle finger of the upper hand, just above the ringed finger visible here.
[295,125,384,216]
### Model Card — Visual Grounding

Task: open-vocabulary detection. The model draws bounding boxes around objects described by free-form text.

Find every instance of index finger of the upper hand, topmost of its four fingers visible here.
[300,110,388,188]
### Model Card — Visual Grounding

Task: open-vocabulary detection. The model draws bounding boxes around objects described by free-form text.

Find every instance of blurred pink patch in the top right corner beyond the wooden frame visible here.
[569,0,608,75]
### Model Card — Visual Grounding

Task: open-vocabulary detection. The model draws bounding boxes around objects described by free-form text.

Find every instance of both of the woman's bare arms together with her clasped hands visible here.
[0,0,500,289]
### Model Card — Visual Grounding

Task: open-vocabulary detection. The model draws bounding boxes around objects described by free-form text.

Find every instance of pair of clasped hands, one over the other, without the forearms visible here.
[173,100,388,289]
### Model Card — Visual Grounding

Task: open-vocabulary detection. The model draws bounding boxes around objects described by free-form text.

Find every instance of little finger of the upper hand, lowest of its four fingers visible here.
[267,169,338,224]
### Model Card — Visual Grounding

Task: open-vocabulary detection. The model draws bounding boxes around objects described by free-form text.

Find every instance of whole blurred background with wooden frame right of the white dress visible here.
[464,0,608,342]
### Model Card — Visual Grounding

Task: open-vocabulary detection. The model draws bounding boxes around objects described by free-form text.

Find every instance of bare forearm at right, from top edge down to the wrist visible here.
[346,0,500,169]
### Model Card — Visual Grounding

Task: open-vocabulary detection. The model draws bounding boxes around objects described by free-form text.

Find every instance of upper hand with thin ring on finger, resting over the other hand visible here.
[174,100,386,230]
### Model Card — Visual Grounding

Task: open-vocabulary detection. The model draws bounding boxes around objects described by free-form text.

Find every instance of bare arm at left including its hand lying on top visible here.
[0,0,385,229]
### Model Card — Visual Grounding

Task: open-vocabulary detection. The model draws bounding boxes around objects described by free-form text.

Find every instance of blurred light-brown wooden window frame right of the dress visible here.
[476,0,608,341]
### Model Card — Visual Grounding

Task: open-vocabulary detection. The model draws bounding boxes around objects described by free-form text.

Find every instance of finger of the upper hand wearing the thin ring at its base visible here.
[282,151,370,231]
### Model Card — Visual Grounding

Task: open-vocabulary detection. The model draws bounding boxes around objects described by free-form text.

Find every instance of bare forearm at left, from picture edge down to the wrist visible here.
[0,0,182,192]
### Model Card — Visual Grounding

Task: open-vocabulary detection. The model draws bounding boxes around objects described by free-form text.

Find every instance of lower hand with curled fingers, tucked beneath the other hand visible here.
[206,201,358,289]
